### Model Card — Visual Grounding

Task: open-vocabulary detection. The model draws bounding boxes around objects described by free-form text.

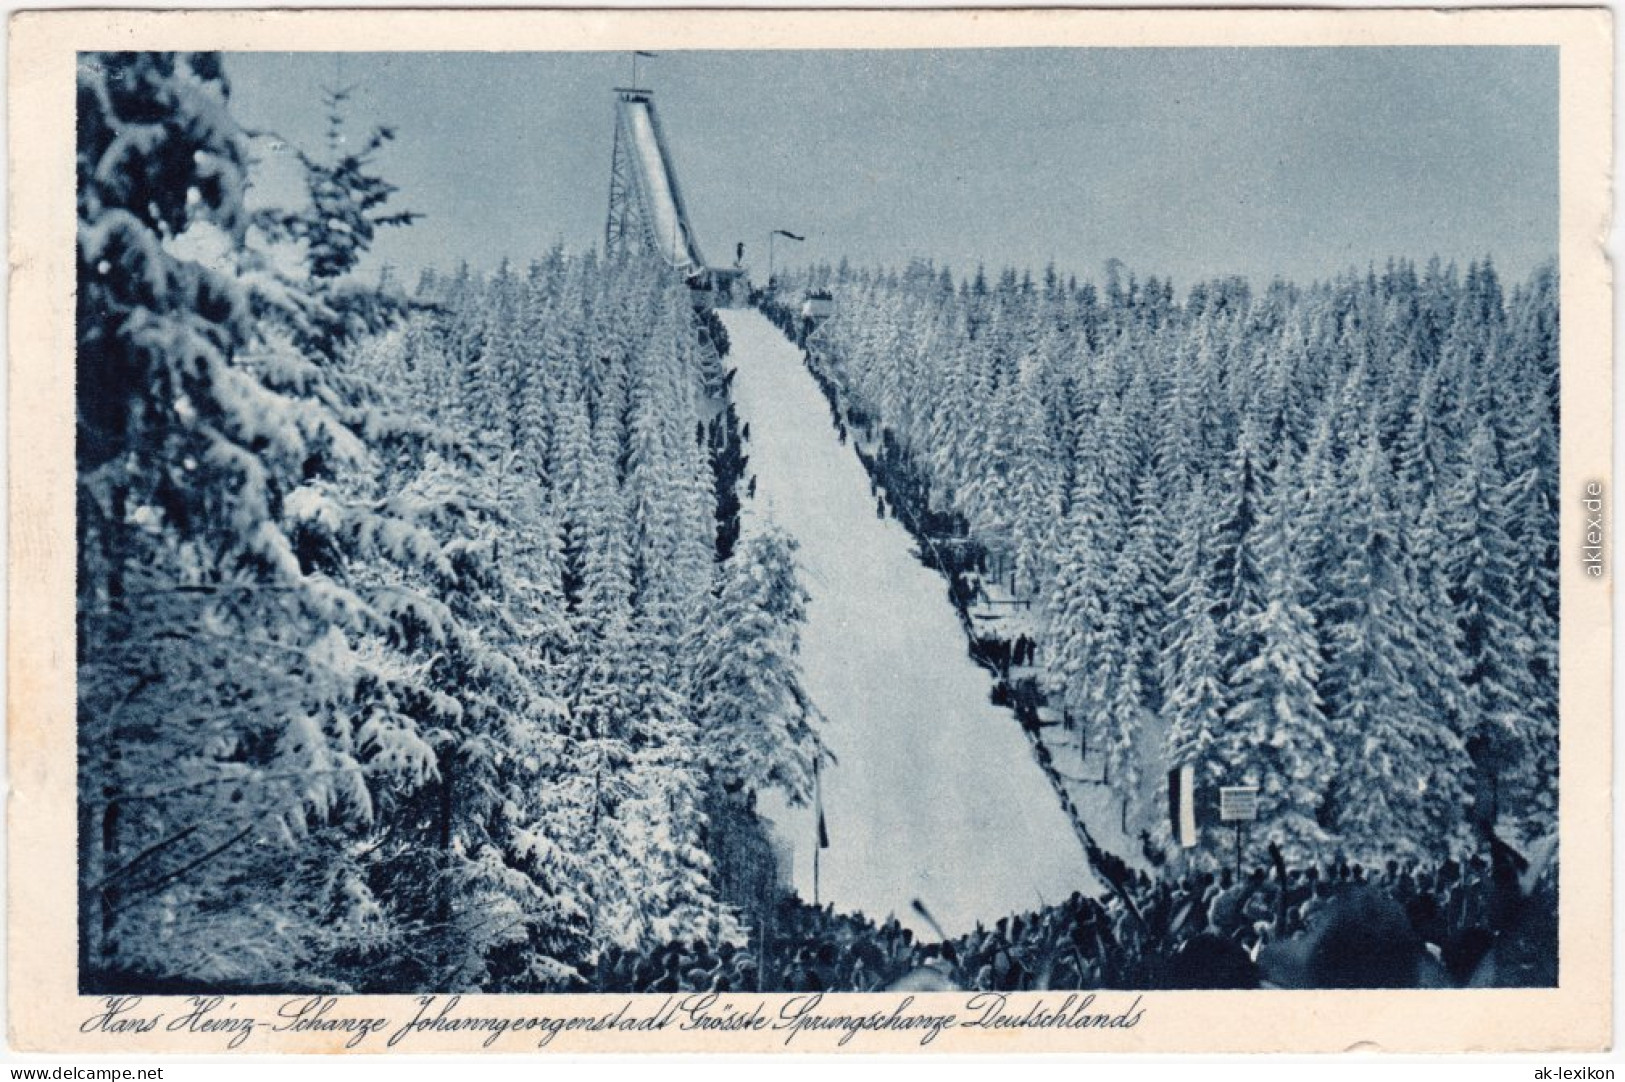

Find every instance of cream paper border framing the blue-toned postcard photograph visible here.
[7,8,1614,1053]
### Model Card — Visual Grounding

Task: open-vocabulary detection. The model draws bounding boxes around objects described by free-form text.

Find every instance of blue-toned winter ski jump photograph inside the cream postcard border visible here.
[75,47,1573,994]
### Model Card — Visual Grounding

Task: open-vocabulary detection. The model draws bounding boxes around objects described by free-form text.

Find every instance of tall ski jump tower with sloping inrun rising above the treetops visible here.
[605,86,744,305]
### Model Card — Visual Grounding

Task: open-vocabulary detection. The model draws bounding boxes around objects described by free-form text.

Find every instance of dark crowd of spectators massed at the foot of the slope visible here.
[583,840,1557,993]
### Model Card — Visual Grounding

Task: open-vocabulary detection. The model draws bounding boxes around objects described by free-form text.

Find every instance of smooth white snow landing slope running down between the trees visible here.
[718,310,1100,937]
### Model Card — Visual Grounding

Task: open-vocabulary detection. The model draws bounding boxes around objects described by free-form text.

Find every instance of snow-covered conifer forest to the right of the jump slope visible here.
[786,260,1558,859]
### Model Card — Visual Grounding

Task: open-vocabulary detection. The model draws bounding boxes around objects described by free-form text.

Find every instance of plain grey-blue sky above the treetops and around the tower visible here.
[228,47,1558,289]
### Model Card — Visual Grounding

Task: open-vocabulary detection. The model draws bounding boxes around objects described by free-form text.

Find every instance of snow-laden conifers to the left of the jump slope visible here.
[78,54,813,991]
